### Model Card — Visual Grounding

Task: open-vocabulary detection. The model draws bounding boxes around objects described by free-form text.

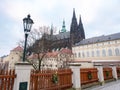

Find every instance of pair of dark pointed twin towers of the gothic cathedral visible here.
[70,9,85,46]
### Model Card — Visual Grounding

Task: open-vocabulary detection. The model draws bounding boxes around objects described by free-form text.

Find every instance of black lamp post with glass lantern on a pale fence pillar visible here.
[23,15,34,62]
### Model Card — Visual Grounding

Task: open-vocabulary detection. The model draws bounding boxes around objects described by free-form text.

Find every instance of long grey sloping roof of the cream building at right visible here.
[75,33,120,46]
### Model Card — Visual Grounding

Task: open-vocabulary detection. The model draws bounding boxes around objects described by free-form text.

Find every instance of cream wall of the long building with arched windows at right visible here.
[72,40,120,60]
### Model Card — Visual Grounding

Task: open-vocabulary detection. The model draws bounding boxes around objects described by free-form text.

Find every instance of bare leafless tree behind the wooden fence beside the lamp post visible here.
[18,26,51,70]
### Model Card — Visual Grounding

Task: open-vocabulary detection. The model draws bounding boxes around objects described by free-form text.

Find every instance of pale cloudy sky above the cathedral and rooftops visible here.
[0,0,120,56]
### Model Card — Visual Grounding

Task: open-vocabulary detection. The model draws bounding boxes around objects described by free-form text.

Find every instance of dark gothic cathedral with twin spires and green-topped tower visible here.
[31,9,85,51]
